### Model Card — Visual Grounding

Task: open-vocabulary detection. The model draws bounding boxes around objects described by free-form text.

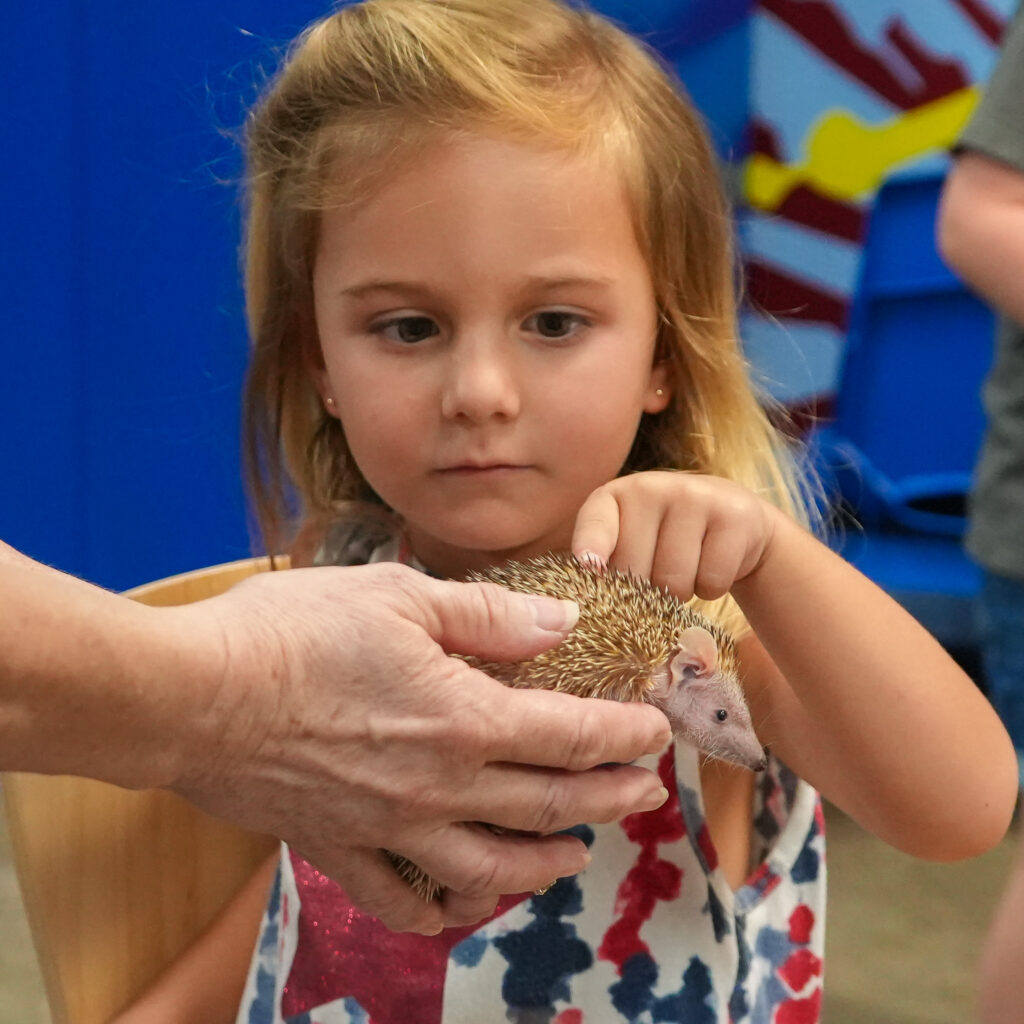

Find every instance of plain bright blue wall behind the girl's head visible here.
[0,0,749,589]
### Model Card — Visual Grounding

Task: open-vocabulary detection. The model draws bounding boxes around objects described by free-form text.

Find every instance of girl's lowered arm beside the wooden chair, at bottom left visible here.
[112,853,278,1024]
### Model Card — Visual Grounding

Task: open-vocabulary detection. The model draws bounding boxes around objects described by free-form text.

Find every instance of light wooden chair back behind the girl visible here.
[3,558,284,1024]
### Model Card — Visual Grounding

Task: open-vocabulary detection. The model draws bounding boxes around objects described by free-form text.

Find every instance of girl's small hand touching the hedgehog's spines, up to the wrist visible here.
[572,472,781,601]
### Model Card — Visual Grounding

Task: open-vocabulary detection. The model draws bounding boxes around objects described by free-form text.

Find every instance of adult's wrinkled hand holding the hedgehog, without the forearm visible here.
[162,564,670,933]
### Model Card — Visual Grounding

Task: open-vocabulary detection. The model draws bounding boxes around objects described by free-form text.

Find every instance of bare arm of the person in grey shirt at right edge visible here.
[938,152,1024,324]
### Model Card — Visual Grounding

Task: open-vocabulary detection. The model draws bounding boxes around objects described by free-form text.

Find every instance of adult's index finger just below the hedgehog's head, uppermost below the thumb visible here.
[488,689,672,771]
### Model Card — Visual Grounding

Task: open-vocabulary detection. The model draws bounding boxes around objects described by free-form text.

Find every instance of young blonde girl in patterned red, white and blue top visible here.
[114,0,1016,1024]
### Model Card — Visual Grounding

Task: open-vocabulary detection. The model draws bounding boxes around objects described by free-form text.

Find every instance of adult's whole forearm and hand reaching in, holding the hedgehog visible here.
[0,546,669,932]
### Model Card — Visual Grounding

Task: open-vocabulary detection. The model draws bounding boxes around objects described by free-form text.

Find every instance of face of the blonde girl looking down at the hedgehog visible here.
[313,137,669,577]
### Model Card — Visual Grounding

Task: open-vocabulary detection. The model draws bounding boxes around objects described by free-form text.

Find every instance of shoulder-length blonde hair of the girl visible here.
[239,0,800,622]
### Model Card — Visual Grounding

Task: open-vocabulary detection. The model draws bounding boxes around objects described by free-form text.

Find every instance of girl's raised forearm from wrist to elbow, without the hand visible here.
[733,513,1017,860]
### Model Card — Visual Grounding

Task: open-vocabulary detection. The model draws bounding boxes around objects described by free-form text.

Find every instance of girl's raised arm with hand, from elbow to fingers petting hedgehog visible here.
[572,473,1017,860]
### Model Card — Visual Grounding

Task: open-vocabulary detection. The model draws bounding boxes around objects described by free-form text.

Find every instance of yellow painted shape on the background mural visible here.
[743,86,980,210]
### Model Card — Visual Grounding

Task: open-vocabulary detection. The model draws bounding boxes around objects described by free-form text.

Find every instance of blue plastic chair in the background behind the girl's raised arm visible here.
[811,171,994,646]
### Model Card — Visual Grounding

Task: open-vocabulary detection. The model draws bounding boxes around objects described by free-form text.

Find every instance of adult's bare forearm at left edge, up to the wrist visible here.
[0,544,203,788]
